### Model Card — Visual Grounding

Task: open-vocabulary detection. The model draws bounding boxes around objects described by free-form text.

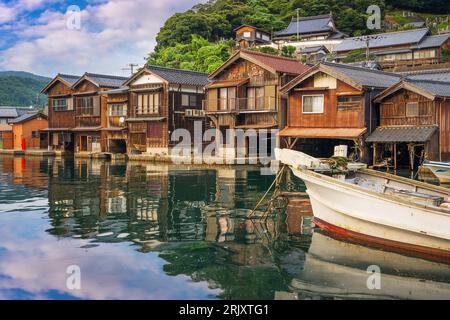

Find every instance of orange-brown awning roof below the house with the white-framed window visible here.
[279,127,367,139]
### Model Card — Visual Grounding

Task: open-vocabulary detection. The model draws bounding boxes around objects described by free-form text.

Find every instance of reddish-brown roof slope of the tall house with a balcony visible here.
[242,50,309,74]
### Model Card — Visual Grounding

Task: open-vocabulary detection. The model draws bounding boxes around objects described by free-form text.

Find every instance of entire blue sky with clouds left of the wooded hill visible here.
[0,0,202,76]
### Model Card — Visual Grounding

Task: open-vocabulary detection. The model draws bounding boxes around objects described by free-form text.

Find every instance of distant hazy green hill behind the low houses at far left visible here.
[0,71,51,107]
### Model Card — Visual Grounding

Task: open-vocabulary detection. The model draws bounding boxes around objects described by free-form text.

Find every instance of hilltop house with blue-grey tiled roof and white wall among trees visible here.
[273,14,344,51]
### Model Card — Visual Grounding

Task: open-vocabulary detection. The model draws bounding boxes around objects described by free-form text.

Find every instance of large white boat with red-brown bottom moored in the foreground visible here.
[276,152,450,261]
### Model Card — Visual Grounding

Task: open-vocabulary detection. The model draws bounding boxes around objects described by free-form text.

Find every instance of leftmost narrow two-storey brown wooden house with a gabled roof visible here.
[42,74,80,152]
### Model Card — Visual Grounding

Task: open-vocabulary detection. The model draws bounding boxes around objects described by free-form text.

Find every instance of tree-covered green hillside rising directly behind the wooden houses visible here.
[148,0,450,72]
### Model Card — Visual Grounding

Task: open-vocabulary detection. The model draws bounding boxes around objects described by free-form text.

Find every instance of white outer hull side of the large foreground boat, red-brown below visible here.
[292,168,450,259]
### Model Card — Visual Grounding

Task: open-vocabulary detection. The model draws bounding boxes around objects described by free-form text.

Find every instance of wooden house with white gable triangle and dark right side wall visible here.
[124,66,208,154]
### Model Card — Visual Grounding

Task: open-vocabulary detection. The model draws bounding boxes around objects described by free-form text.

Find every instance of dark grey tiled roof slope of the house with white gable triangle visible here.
[147,65,209,87]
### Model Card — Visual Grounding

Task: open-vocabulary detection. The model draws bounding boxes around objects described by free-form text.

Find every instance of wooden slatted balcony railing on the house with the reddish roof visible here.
[203,97,278,113]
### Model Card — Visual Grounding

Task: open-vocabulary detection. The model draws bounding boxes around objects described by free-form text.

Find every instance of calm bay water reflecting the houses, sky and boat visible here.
[0,156,450,299]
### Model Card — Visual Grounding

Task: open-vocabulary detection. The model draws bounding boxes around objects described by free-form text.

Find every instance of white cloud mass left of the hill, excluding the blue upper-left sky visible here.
[0,0,206,76]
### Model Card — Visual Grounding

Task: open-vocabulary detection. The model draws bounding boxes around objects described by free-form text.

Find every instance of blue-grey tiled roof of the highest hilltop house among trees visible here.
[275,14,334,37]
